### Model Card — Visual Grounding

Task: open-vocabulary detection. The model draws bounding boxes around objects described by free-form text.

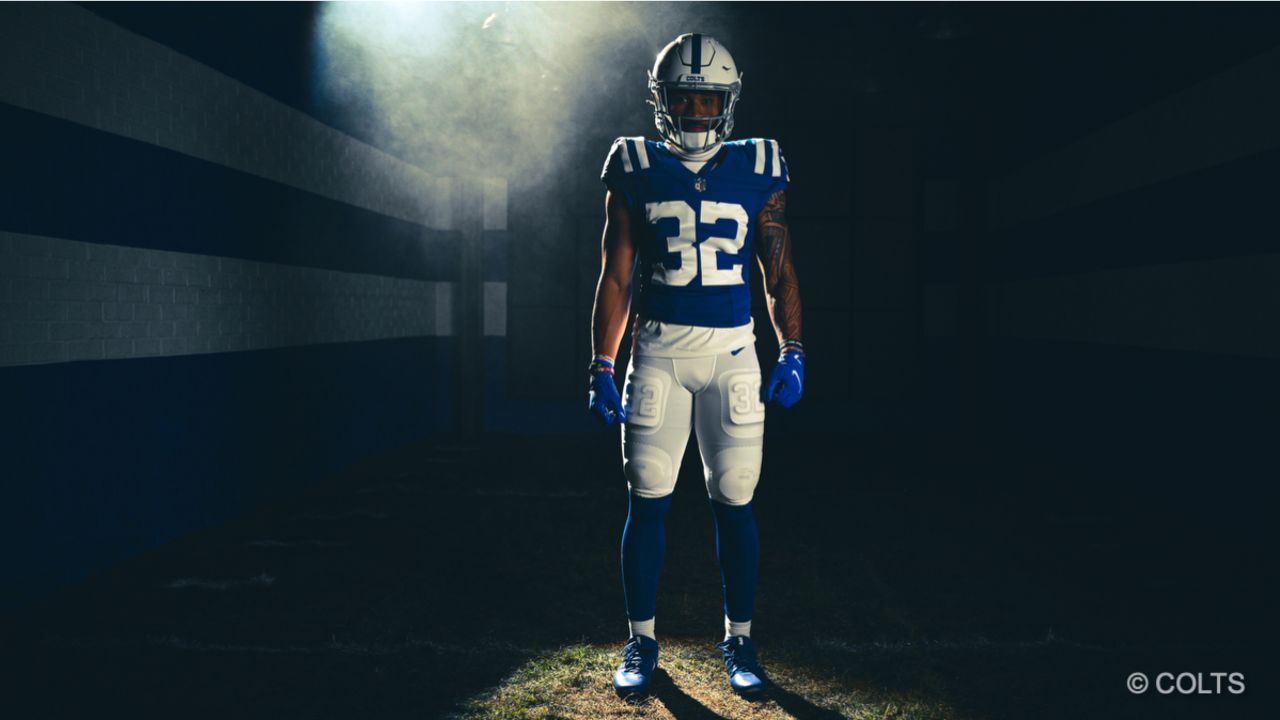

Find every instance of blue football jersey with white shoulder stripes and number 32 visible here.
[602,137,788,328]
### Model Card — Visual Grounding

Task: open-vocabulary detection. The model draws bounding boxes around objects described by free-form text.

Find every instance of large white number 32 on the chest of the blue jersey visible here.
[644,200,749,286]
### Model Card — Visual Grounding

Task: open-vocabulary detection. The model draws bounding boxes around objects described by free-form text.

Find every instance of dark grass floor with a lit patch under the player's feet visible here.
[3,427,1266,720]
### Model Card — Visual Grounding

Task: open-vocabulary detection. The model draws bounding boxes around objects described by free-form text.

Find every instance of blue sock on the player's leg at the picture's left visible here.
[622,495,671,620]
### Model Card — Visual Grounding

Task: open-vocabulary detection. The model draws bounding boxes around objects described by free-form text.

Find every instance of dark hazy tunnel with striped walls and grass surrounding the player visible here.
[0,3,1280,719]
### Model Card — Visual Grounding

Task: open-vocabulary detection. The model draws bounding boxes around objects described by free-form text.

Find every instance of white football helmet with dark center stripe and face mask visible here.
[649,32,742,152]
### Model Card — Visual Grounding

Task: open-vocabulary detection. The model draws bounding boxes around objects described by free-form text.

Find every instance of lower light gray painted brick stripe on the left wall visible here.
[0,232,455,366]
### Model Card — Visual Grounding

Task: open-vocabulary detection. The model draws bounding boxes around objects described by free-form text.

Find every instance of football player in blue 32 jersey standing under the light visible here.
[589,33,804,696]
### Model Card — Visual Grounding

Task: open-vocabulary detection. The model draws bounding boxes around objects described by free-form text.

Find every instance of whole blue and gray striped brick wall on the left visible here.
[0,4,478,607]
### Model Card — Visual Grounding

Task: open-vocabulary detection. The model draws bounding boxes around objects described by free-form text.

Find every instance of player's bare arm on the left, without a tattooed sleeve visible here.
[591,192,636,357]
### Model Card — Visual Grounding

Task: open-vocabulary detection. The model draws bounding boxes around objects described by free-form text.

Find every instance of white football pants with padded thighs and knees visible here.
[622,346,764,505]
